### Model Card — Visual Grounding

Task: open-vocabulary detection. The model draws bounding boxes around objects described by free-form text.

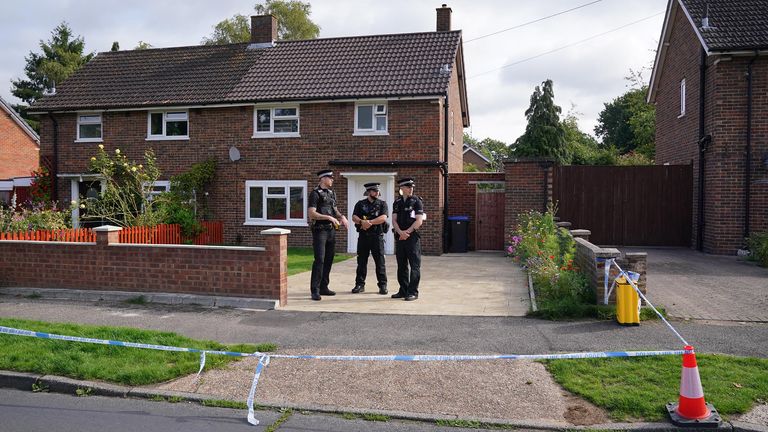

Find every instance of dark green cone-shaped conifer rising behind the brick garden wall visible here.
[513,79,568,163]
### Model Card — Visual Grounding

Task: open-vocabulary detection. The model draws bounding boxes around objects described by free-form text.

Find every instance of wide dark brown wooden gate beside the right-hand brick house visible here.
[552,165,693,246]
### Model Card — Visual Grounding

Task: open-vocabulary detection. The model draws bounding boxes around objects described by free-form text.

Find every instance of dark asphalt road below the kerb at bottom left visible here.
[0,389,504,432]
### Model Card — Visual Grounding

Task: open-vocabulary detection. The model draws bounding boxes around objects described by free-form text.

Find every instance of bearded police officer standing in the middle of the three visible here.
[352,183,389,294]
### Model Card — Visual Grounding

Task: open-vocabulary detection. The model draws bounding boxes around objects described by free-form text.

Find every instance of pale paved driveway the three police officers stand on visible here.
[280,252,529,316]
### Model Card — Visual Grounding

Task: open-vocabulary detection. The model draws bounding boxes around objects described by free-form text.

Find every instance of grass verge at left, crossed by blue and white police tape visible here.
[0,318,277,385]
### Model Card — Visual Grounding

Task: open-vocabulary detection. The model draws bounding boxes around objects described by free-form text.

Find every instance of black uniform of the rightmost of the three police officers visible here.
[392,195,424,298]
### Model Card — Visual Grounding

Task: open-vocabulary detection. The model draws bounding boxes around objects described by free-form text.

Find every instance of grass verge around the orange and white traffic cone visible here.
[545,354,768,420]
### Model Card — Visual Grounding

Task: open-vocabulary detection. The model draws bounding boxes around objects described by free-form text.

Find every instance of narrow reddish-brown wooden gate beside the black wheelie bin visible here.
[475,188,504,250]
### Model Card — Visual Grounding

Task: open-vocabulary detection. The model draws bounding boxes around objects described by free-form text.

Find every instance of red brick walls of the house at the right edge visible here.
[656,6,768,254]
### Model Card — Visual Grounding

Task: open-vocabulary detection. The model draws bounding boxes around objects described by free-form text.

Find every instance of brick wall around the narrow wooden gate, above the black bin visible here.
[448,173,504,250]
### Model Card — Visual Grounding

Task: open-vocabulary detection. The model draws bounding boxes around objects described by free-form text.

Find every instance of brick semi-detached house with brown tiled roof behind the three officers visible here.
[32,6,469,254]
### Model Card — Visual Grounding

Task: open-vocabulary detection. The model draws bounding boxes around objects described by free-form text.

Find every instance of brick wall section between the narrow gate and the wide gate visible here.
[504,160,553,244]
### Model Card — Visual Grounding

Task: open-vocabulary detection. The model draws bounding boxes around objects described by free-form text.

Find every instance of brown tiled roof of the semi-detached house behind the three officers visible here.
[33,31,461,111]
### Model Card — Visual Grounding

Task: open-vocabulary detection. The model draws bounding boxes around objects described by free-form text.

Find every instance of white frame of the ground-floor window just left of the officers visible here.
[243,180,308,226]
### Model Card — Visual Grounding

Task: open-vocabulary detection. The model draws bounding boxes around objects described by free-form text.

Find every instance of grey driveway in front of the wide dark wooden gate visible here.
[632,248,768,322]
